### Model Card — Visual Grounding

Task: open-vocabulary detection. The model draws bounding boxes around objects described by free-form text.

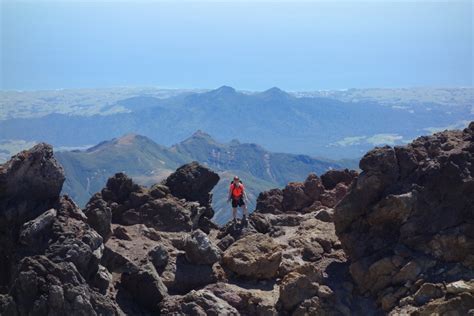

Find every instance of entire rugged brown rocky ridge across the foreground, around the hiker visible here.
[0,123,474,315]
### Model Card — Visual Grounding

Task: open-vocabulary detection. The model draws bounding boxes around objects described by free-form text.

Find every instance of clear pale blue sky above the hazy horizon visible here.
[0,0,474,91]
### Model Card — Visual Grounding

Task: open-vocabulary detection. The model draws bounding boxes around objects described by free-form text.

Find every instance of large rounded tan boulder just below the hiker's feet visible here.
[223,233,281,279]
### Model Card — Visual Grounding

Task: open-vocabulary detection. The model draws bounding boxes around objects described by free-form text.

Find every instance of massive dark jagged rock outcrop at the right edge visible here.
[335,122,474,314]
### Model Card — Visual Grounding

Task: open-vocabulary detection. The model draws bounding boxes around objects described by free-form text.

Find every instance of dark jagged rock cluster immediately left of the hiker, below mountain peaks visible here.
[84,163,219,232]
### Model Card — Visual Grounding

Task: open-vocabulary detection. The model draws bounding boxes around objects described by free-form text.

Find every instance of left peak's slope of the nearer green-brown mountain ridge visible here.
[56,134,189,205]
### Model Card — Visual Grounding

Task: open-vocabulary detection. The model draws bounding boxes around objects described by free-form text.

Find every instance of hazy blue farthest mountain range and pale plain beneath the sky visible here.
[0,86,474,159]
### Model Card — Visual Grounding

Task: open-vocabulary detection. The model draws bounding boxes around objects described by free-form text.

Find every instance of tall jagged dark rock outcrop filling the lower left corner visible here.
[0,144,120,315]
